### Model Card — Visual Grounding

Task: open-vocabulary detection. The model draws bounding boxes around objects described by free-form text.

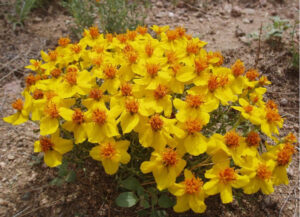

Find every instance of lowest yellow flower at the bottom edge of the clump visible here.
[168,169,206,213]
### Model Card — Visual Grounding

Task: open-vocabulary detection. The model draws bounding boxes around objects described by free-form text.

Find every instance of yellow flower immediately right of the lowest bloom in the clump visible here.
[203,157,249,203]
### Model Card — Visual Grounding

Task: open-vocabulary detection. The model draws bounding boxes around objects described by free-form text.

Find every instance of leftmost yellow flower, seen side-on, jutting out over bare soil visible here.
[3,92,32,125]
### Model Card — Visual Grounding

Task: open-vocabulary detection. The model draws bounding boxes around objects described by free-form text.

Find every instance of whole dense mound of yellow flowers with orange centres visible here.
[4,25,296,213]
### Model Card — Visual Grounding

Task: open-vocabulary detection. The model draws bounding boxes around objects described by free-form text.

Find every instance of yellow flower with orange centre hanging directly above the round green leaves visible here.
[90,139,130,175]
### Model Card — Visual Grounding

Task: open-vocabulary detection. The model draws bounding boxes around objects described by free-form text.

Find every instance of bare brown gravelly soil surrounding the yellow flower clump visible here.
[0,0,300,217]
